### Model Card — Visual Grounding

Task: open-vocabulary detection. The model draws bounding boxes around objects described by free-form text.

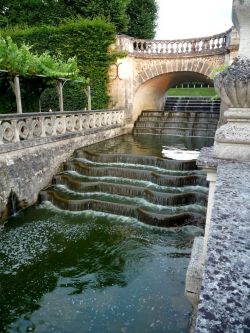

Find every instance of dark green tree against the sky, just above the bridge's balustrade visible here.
[127,0,158,39]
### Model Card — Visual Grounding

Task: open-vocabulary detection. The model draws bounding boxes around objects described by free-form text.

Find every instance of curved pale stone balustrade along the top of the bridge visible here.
[118,29,231,56]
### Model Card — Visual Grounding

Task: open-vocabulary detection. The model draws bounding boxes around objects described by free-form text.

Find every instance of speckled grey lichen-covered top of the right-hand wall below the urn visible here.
[195,158,250,333]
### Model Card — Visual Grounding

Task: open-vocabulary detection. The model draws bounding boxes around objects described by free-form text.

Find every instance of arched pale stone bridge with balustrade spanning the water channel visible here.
[109,28,239,123]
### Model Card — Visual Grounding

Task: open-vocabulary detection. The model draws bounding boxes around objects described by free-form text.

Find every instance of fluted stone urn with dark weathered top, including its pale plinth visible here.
[214,57,250,161]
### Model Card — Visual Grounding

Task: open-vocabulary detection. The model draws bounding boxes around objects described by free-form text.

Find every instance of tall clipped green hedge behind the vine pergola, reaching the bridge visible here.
[2,18,117,110]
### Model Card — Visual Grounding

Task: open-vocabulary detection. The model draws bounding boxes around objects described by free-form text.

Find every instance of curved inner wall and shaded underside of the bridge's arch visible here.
[133,71,213,121]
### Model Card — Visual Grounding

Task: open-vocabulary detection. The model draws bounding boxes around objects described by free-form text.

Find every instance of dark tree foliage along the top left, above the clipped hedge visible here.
[0,0,130,32]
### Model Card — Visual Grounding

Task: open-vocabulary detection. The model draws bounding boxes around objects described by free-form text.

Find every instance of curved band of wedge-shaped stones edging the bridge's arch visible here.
[134,59,215,90]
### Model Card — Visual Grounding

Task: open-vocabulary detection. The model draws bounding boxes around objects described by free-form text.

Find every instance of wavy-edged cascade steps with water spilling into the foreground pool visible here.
[40,148,207,227]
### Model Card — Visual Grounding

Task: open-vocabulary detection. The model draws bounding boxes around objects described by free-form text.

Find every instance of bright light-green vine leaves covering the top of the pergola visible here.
[0,36,82,80]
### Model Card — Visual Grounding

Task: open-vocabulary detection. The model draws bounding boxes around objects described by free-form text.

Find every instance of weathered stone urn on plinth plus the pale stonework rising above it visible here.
[214,0,250,161]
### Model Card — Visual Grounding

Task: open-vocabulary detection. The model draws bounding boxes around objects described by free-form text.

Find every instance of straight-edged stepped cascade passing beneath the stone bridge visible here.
[133,97,220,138]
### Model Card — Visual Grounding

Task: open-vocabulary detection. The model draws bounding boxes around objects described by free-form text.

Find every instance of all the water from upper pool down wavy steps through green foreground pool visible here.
[0,135,212,333]
